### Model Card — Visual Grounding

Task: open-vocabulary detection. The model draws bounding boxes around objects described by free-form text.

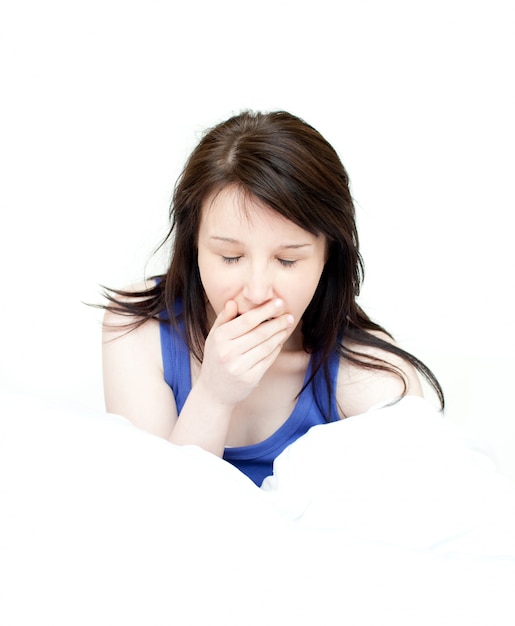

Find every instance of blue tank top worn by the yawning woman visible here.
[160,300,339,486]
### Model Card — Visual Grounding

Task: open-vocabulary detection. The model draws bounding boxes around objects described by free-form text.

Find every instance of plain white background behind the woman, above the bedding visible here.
[0,0,515,476]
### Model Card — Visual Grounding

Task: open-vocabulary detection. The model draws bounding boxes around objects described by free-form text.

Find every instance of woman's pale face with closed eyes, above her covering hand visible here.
[198,186,326,348]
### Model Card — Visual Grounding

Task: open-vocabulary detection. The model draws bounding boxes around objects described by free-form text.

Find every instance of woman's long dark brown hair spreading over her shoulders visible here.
[106,111,443,407]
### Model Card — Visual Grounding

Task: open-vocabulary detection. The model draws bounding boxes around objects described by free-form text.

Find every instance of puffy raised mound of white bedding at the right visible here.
[263,397,515,558]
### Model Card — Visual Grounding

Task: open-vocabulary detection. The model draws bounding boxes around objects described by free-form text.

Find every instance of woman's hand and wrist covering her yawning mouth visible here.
[197,299,294,406]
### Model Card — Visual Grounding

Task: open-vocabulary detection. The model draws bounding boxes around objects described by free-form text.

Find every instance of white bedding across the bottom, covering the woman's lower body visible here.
[0,392,515,626]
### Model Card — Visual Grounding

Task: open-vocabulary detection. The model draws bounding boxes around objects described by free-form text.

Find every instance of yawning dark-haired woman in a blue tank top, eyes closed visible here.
[103,112,443,485]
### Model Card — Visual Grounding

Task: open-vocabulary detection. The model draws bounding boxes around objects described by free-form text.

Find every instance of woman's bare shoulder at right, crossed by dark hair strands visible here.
[336,331,423,417]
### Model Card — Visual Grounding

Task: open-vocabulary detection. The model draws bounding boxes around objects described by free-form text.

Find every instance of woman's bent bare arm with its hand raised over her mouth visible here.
[103,292,292,456]
